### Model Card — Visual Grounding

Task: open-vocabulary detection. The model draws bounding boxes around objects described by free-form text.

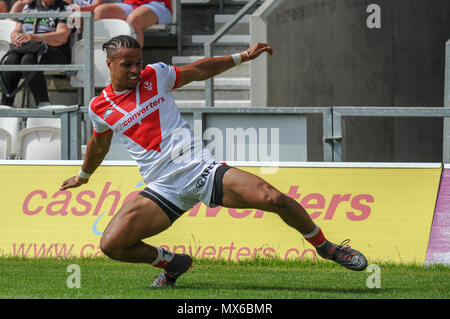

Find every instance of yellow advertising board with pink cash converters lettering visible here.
[0,163,441,264]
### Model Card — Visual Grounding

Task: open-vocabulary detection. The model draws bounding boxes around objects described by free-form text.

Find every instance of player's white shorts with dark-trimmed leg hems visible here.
[141,159,229,219]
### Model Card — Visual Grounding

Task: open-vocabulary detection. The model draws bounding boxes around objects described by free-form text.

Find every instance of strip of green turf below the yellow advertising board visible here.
[0,257,450,299]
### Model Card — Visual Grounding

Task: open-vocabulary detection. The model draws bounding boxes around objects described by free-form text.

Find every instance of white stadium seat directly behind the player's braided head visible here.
[70,19,136,88]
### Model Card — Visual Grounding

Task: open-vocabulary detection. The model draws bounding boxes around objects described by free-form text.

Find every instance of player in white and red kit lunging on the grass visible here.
[61,36,367,287]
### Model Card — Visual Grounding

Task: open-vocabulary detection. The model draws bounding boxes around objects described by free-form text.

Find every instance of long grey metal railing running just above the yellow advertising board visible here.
[4,105,450,163]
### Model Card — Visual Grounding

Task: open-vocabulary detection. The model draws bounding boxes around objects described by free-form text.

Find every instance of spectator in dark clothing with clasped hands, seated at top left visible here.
[1,0,72,106]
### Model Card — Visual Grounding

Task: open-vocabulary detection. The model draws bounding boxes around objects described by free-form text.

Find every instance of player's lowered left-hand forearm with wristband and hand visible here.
[59,131,113,190]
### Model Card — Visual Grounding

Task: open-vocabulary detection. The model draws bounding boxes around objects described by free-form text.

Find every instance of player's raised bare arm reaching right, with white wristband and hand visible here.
[177,43,273,88]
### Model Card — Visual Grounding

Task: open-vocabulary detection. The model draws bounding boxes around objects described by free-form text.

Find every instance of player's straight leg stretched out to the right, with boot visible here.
[222,168,367,271]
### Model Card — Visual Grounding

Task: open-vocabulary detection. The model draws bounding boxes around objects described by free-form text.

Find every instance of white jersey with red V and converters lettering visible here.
[89,63,209,184]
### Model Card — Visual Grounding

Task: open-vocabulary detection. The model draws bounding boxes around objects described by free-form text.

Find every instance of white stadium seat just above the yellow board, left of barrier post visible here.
[17,105,68,160]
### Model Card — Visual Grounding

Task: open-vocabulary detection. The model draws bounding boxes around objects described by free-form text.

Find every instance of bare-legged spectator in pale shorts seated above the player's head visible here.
[94,0,172,47]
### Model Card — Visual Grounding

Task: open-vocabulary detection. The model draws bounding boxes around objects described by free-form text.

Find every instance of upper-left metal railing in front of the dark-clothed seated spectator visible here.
[0,12,94,110]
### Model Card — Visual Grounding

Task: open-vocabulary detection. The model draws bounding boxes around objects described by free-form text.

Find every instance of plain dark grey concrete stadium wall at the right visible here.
[250,0,450,162]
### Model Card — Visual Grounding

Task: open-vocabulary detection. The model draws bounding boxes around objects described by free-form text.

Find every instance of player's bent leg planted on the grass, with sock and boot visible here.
[100,195,192,287]
